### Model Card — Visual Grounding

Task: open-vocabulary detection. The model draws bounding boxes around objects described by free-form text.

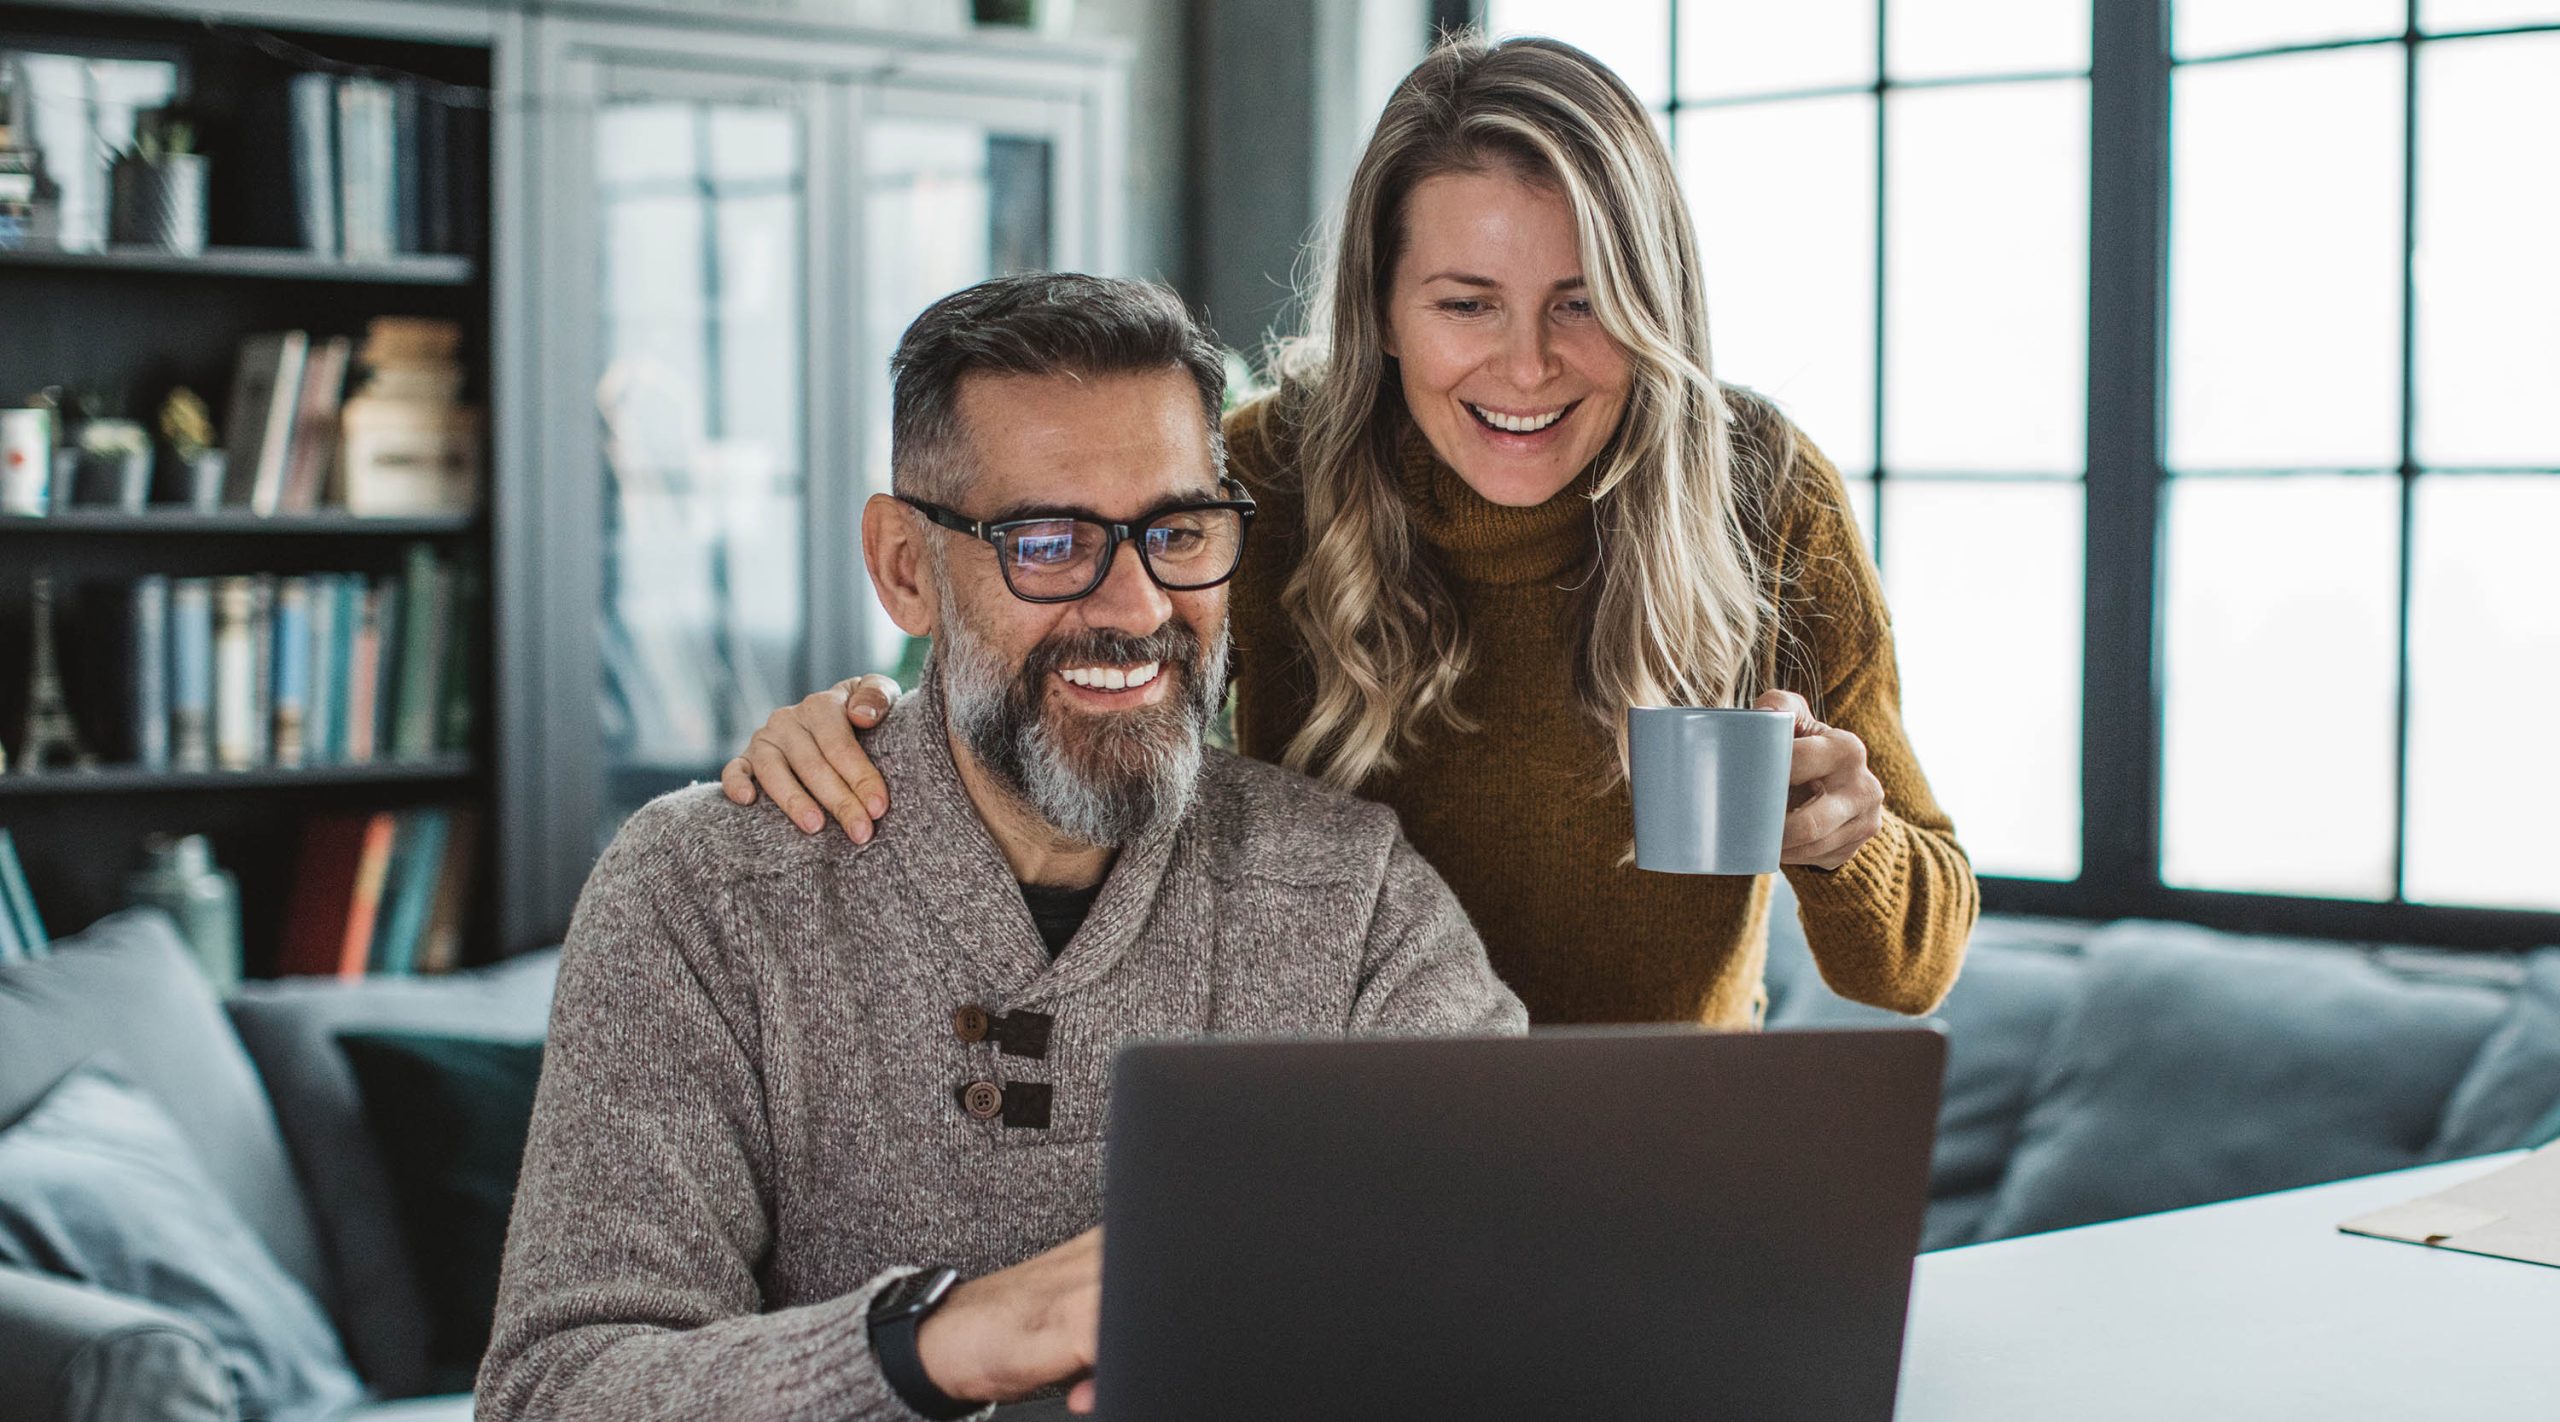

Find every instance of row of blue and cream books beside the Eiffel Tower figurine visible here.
[74,543,481,771]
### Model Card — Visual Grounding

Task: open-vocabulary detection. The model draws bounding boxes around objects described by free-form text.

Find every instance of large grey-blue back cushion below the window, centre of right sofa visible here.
[1984,922,2509,1240]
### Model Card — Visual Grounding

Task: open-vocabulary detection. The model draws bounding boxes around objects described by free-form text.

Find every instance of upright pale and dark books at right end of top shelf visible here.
[238,72,489,261]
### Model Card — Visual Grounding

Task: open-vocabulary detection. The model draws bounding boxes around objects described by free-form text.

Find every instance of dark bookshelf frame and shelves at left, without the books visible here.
[0,0,499,976]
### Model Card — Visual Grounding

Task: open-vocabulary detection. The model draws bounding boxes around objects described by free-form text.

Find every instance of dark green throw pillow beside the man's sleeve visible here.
[338,1033,543,1391]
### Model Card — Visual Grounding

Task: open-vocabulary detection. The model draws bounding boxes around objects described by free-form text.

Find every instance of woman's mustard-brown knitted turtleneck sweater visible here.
[1226,397,1976,1027]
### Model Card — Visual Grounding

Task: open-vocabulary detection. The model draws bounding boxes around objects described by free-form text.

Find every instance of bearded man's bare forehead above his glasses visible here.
[960,369,1216,518]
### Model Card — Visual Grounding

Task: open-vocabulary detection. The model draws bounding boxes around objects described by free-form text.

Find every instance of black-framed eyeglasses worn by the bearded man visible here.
[899,479,1254,602]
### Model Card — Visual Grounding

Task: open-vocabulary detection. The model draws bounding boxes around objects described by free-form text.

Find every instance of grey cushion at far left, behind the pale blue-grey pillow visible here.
[0,910,328,1296]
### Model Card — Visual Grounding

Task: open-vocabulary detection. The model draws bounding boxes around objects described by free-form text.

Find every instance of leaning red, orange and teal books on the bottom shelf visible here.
[276,807,479,979]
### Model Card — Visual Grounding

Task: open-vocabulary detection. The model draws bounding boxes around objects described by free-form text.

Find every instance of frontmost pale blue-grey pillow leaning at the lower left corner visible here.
[0,1063,364,1422]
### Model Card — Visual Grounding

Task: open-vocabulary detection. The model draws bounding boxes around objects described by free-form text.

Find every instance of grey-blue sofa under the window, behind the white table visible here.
[1769,881,2560,1250]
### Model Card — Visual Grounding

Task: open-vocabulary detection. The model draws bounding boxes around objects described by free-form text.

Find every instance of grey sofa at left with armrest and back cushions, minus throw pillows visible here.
[0,910,558,1422]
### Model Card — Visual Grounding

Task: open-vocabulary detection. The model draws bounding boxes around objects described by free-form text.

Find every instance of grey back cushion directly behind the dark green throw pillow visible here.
[230,951,561,1396]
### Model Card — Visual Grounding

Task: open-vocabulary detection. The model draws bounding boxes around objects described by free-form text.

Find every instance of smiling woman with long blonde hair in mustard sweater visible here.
[722,38,1976,1027]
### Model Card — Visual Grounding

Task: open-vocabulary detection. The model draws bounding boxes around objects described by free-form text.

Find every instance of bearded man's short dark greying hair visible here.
[888,272,1226,502]
